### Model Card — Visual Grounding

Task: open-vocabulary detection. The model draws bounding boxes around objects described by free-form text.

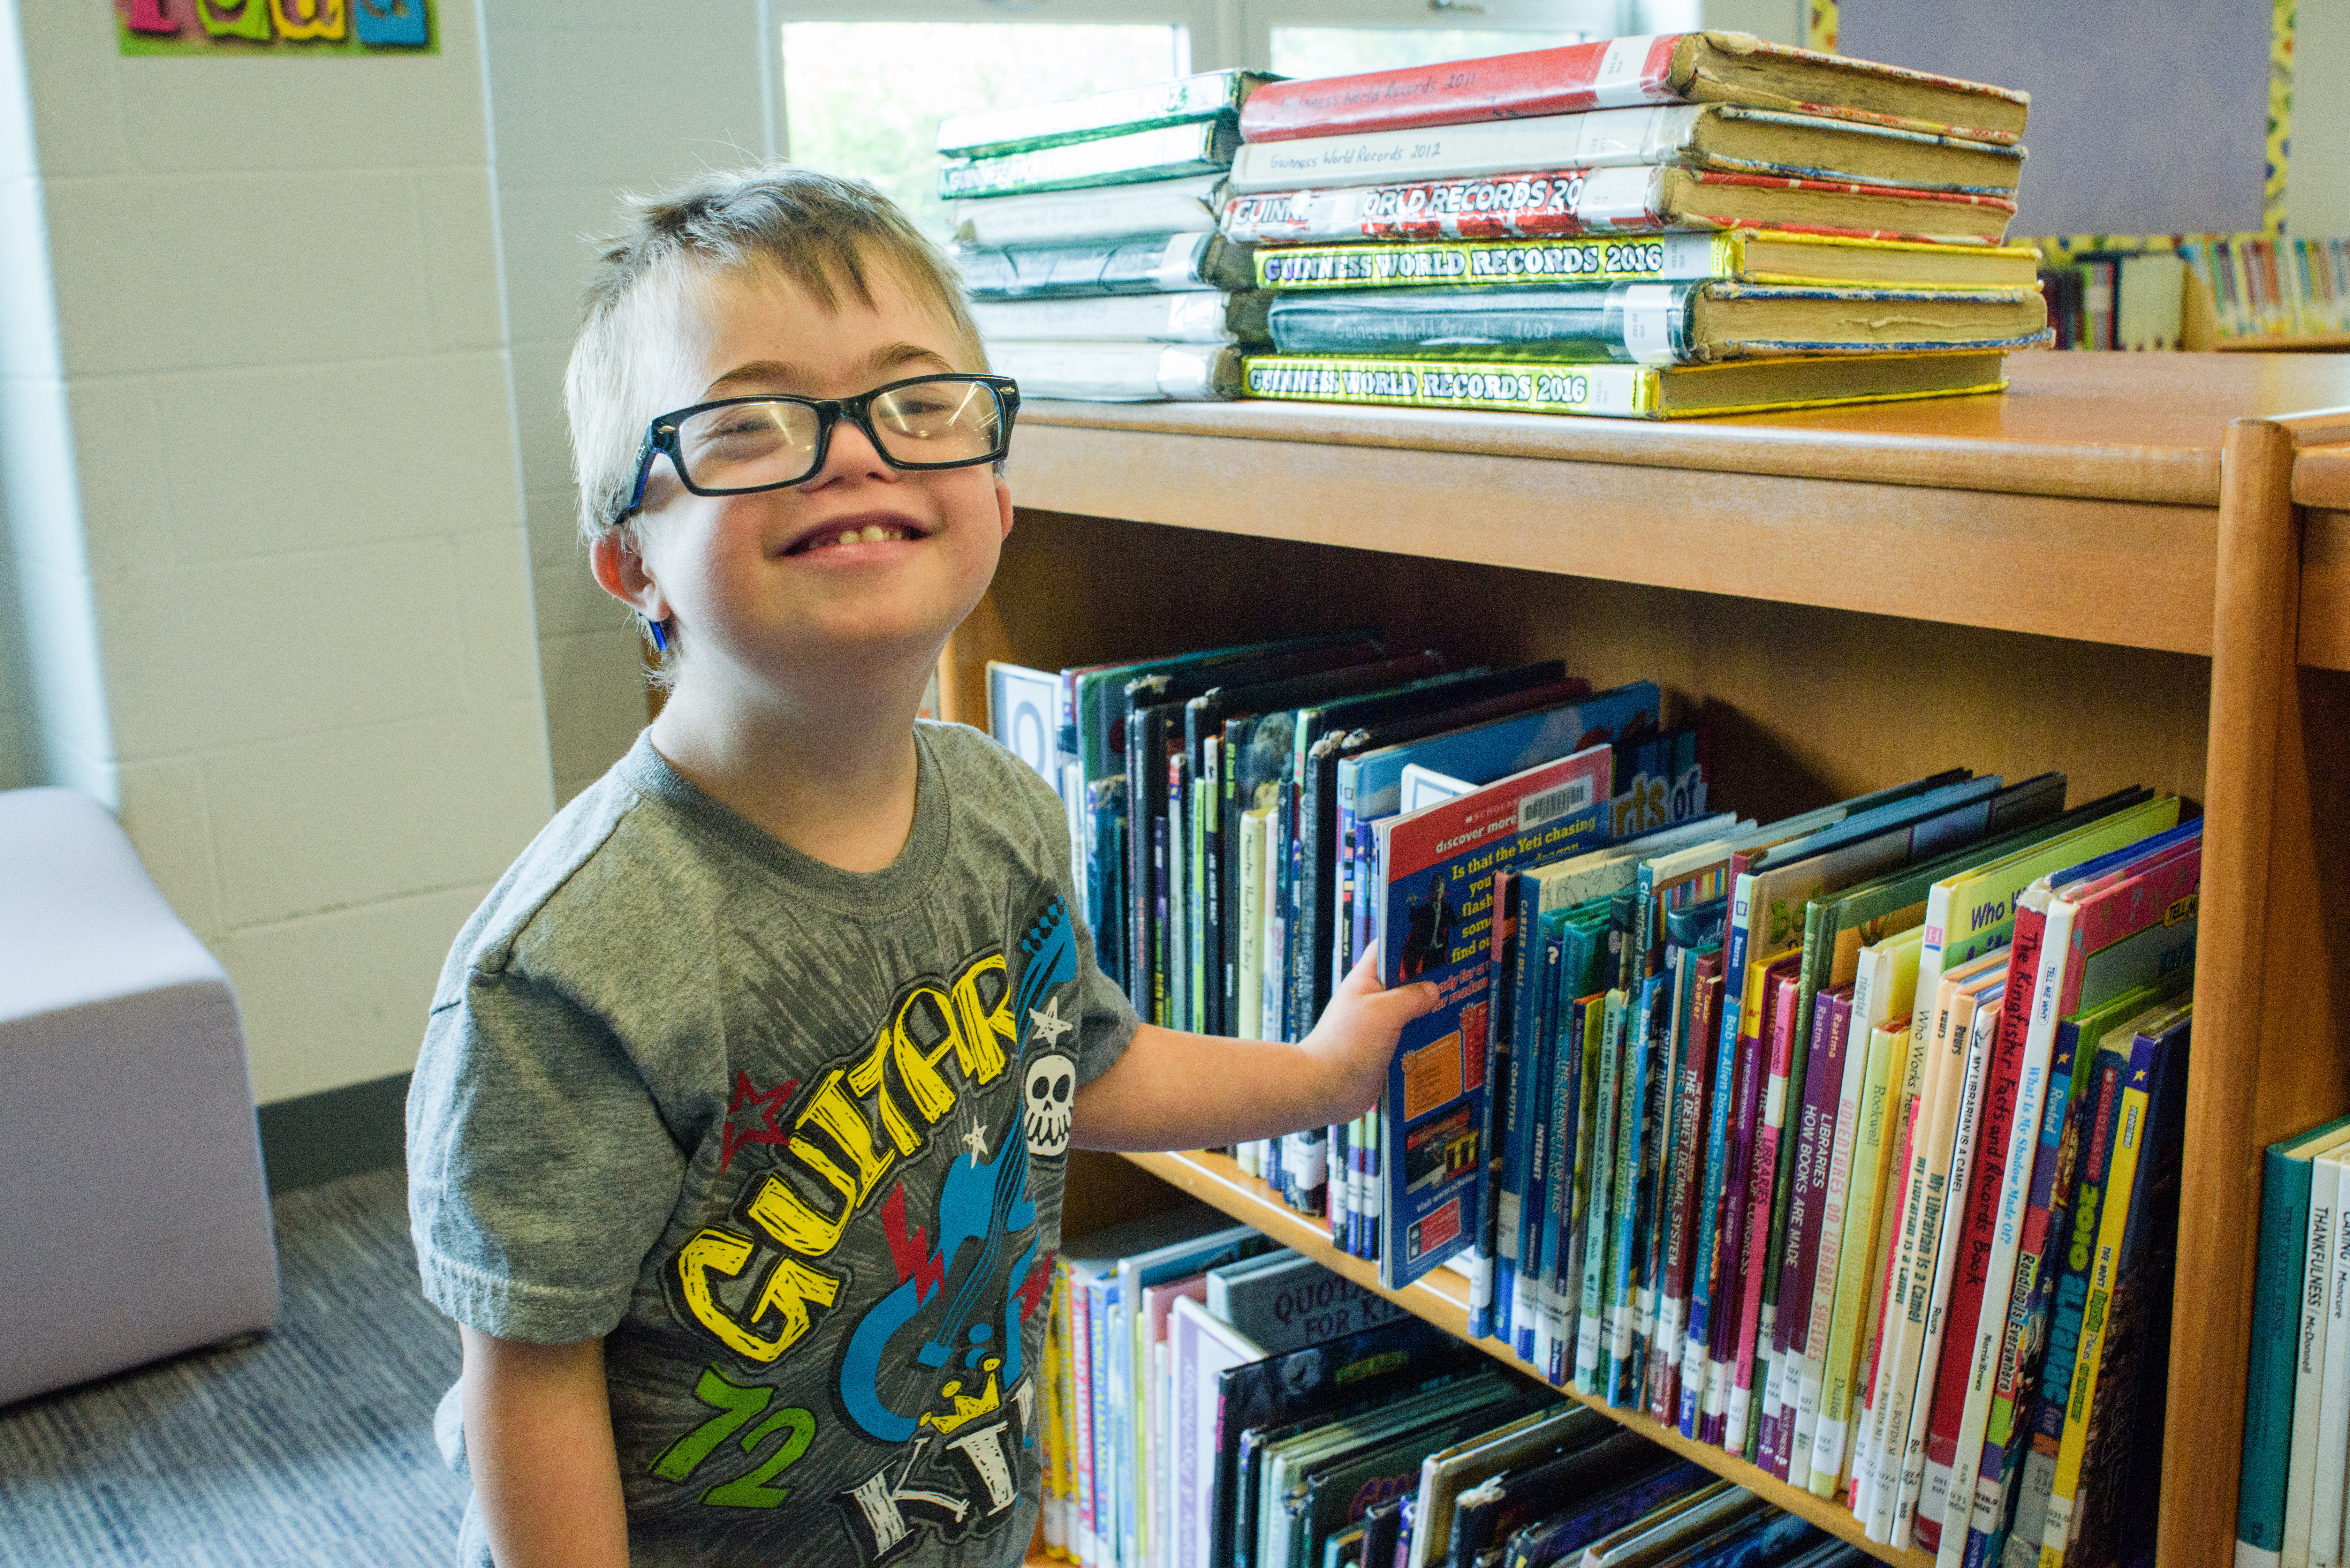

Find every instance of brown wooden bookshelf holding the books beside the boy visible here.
[942,353,2350,1568]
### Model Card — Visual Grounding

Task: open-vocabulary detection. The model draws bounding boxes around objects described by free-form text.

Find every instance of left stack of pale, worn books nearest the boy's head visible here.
[938,71,1274,402]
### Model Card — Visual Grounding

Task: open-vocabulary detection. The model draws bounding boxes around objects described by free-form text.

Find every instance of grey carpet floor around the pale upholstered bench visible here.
[0,1171,465,1568]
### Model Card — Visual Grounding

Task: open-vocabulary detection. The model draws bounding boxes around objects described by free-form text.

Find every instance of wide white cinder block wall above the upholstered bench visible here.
[0,0,552,1103]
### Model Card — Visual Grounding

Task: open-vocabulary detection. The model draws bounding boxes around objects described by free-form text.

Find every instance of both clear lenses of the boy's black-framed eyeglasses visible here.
[677,381,1004,491]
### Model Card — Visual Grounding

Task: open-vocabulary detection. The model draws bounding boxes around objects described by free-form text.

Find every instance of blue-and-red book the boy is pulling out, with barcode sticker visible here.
[1377,741,1614,1291]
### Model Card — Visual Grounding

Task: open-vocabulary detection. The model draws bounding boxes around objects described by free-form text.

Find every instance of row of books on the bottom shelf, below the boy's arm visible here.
[1041,1208,1868,1568]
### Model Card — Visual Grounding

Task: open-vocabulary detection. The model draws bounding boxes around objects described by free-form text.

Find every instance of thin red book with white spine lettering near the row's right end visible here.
[1911,908,2047,1551]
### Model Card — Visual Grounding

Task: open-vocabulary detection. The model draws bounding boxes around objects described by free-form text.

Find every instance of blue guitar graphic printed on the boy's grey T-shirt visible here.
[839,898,1076,1444]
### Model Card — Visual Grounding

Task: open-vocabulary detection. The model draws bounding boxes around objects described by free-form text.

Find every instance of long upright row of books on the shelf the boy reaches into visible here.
[994,630,2199,1568]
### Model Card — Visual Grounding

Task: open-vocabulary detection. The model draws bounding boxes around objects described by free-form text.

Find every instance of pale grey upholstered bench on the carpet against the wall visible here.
[0,790,277,1403]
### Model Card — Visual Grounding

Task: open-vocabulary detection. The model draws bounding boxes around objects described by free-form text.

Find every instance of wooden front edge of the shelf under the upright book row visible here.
[1128,1150,1934,1568]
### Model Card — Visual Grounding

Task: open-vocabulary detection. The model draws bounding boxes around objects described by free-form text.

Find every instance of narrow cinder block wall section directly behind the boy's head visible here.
[489,0,783,802]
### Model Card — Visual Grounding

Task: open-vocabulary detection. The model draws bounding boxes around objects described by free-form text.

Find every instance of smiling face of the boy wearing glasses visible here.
[599,266,1013,686]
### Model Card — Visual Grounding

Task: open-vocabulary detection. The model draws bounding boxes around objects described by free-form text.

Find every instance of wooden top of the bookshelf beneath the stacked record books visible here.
[1013,353,2350,505]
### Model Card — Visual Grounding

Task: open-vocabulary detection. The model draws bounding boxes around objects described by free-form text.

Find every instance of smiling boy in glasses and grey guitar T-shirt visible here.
[409,169,1434,1568]
